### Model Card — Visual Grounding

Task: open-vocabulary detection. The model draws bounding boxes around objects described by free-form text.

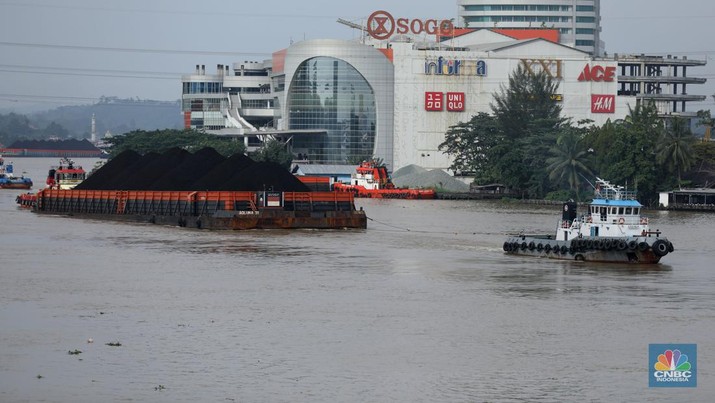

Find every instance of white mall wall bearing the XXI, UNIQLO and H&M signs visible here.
[392,42,628,169]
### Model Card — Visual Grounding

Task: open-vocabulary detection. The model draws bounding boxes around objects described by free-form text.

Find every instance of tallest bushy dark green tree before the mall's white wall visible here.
[440,66,565,197]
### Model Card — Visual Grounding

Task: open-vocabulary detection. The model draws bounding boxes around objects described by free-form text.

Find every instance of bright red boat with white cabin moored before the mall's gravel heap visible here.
[333,161,436,199]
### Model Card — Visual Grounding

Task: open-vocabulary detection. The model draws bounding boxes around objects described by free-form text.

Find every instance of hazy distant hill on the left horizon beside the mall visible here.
[28,97,183,139]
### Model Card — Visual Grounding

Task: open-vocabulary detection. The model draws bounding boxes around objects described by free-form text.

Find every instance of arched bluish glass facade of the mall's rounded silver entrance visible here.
[288,57,377,164]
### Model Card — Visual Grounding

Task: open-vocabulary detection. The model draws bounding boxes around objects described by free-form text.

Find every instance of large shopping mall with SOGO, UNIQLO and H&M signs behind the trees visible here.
[182,11,705,170]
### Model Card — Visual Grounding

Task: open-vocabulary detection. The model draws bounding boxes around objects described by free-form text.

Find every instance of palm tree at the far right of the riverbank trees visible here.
[655,117,695,187]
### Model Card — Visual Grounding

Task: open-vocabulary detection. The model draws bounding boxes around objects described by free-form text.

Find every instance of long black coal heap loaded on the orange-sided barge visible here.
[76,148,310,192]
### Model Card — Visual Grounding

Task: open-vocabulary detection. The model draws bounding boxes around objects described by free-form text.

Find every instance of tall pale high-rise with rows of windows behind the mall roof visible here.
[457,0,605,56]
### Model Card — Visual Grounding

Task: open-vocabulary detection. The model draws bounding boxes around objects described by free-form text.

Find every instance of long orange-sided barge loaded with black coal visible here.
[27,149,367,230]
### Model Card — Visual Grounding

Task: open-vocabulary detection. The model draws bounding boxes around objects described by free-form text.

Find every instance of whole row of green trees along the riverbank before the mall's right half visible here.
[440,67,715,205]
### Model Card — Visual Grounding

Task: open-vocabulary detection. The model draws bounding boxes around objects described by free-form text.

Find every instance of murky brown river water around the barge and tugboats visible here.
[0,158,715,402]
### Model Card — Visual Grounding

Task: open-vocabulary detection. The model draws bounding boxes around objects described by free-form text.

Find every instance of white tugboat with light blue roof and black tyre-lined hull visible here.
[503,178,674,264]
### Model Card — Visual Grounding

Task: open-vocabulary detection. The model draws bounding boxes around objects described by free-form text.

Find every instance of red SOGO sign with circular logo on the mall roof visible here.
[367,10,454,40]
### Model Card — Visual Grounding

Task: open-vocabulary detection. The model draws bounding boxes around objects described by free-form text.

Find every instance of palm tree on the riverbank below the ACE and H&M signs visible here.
[546,127,593,199]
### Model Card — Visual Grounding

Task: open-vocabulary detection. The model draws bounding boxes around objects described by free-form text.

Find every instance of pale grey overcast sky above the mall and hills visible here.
[0,0,715,111]
